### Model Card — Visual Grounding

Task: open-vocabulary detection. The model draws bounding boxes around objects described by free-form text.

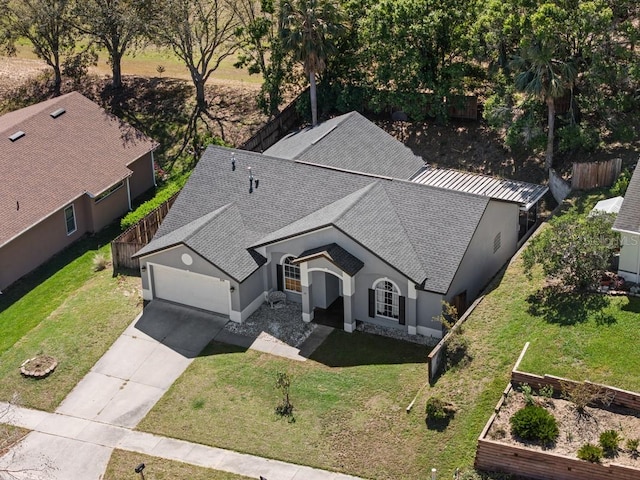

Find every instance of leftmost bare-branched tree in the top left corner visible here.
[0,0,77,95]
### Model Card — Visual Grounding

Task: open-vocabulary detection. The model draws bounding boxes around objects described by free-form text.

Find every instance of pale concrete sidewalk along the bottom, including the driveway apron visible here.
[0,403,358,480]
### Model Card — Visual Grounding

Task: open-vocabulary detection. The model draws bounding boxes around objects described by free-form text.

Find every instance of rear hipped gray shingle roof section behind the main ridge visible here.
[264,112,424,179]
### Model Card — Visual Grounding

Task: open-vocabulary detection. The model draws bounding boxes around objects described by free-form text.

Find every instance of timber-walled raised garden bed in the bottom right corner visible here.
[475,344,640,480]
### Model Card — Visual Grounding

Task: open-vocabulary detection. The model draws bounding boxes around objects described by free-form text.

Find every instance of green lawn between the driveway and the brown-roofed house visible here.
[0,231,142,411]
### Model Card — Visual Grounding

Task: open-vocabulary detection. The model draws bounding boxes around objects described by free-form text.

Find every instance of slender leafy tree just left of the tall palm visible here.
[235,0,291,115]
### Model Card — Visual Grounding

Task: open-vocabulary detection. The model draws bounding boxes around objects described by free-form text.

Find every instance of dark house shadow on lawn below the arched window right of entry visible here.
[309,330,431,367]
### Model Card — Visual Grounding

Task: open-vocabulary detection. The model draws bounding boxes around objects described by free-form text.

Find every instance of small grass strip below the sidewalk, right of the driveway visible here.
[102,450,249,480]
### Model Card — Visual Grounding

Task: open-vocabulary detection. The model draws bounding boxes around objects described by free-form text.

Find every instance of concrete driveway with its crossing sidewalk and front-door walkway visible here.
[0,301,342,480]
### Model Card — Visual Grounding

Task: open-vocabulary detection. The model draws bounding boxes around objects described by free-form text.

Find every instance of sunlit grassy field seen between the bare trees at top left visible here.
[10,40,262,85]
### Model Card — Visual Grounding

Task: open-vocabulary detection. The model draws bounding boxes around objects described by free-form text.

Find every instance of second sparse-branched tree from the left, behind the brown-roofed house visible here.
[74,0,153,89]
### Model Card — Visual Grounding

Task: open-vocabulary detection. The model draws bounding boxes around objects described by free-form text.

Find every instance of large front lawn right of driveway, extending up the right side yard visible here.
[139,193,640,479]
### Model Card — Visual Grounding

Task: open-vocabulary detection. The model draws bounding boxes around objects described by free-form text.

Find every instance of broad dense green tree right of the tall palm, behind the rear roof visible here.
[359,0,477,120]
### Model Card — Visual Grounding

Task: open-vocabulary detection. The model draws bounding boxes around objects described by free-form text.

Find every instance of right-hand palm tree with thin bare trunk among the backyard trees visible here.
[511,41,578,170]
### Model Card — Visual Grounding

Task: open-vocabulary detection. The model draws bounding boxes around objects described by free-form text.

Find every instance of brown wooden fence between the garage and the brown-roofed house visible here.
[111,193,178,274]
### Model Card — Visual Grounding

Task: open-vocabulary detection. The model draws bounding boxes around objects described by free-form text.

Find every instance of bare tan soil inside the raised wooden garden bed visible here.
[487,391,640,469]
